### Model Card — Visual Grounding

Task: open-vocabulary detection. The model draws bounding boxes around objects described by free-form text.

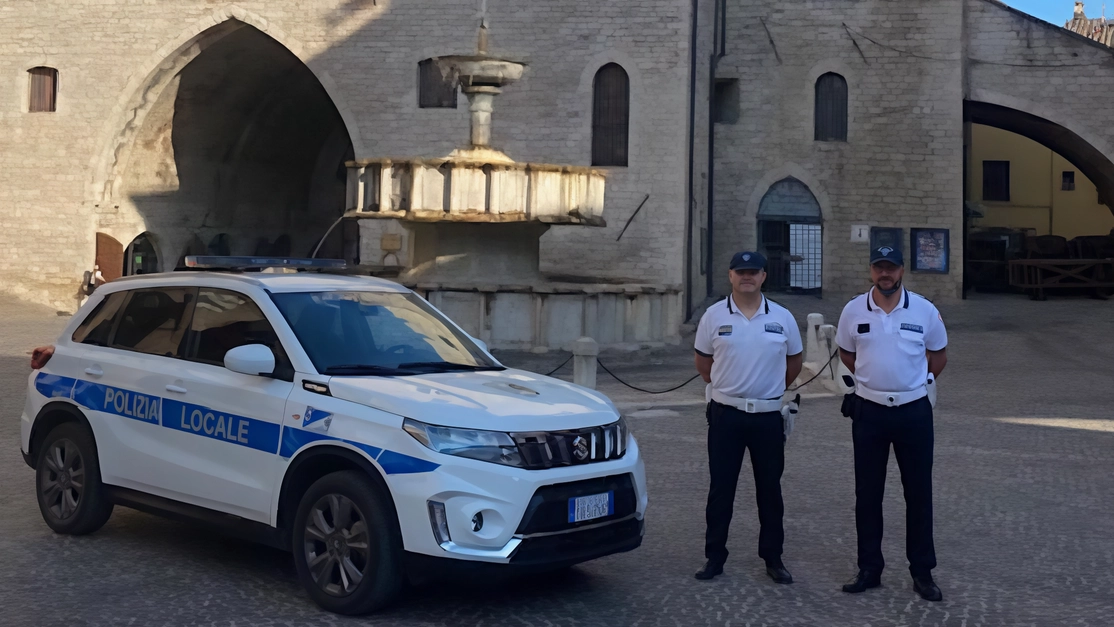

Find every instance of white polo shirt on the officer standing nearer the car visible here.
[696,295,804,399]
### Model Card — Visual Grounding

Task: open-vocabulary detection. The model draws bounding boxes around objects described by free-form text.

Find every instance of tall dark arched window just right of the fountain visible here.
[592,63,631,166]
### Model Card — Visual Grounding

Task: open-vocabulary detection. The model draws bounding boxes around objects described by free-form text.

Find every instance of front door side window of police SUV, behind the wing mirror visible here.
[189,287,285,365]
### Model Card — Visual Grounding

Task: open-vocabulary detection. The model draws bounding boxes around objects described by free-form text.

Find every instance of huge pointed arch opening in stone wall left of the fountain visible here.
[98,20,358,271]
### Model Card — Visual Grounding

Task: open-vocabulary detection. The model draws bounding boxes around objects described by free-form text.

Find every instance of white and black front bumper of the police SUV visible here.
[388,438,647,568]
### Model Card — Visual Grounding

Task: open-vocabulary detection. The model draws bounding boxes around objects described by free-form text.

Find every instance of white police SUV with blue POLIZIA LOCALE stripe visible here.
[21,257,646,614]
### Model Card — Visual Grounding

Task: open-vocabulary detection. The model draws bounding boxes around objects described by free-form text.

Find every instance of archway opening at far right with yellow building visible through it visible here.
[964,100,1114,293]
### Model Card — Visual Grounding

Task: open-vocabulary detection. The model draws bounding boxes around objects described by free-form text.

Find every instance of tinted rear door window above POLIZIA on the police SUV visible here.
[111,287,196,356]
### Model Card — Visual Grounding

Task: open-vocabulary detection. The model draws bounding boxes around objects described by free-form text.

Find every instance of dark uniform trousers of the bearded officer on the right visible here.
[851,398,936,576]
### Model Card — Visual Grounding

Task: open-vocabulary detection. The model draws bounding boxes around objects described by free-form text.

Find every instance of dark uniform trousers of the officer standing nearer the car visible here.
[704,401,785,562]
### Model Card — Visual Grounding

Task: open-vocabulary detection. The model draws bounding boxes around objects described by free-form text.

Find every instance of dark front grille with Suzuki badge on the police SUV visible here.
[511,422,629,470]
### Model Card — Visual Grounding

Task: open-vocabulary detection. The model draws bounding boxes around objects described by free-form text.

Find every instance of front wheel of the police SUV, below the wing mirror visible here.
[292,470,403,616]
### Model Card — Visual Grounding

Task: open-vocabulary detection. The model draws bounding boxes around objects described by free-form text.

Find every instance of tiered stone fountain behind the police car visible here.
[334,25,681,351]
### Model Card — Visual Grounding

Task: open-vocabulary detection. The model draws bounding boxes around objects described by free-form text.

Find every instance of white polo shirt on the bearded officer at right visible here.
[836,288,948,392]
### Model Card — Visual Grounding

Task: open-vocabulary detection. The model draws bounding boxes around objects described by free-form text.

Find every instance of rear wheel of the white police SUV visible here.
[35,422,113,536]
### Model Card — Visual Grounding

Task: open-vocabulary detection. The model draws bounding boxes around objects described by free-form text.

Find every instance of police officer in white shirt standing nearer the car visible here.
[695,253,803,584]
